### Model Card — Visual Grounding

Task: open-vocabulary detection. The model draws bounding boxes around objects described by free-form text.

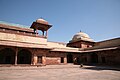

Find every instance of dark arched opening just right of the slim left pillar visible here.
[17,49,32,64]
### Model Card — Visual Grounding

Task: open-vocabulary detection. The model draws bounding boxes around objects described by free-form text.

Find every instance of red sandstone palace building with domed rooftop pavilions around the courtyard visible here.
[0,19,120,65]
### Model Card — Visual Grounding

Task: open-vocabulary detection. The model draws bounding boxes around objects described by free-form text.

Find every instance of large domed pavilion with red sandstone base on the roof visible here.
[67,31,94,48]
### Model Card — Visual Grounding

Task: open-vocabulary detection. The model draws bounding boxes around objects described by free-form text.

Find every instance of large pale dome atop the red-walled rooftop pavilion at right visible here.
[72,32,93,42]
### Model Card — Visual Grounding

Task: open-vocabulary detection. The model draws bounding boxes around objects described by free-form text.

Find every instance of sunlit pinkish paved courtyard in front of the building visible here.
[0,64,120,80]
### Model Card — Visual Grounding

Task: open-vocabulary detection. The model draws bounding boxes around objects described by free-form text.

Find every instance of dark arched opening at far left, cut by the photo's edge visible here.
[0,48,15,64]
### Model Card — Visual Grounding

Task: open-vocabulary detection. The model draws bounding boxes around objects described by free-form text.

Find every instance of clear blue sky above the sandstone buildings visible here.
[0,0,120,42]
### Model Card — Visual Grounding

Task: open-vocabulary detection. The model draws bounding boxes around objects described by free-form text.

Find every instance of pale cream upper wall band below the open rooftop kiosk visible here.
[0,32,47,44]
